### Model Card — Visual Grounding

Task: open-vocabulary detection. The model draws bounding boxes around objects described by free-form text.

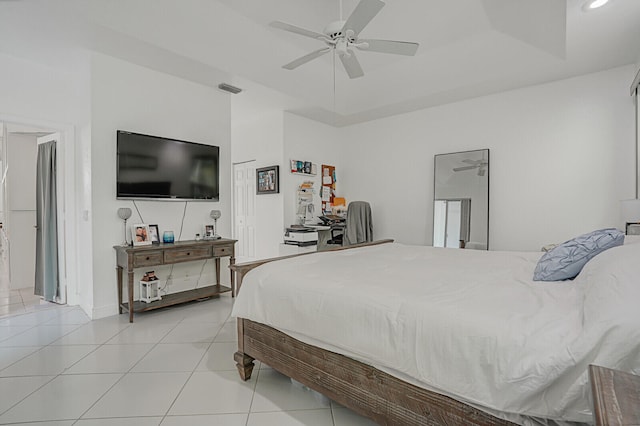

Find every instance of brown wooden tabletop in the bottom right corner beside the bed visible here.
[589,365,640,425]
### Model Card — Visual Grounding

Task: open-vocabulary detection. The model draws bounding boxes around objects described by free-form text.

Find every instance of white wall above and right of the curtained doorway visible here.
[0,53,92,311]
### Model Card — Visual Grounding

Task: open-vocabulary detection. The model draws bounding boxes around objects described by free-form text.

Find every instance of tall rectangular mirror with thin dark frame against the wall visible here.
[433,149,489,250]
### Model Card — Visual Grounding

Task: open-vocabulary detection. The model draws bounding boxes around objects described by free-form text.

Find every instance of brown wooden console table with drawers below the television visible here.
[113,238,236,322]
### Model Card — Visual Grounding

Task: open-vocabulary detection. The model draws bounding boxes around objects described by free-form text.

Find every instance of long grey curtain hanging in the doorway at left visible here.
[35,141,60,302]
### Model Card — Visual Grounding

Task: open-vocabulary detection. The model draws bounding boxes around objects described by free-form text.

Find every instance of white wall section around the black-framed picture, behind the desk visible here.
[232,101,342,258]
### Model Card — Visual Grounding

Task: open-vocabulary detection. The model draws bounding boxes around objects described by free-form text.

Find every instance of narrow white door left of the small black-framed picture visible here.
[233,161,256,263]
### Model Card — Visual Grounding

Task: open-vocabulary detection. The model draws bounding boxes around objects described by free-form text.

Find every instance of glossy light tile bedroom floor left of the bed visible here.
[0,294,374,426]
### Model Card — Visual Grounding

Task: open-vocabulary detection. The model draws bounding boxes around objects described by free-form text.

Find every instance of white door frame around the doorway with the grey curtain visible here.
[0,114,80,305]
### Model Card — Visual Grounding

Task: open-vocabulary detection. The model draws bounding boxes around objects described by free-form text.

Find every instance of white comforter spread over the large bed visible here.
[232,244,640,422]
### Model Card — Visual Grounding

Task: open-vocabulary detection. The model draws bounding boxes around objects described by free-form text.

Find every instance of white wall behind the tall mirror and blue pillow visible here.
[341,66,635,250]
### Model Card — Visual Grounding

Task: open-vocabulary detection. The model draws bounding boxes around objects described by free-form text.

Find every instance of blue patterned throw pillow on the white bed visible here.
[533,228,624,281]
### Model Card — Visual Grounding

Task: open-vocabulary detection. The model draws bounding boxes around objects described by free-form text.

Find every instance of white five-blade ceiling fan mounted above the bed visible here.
[269,0,419,78]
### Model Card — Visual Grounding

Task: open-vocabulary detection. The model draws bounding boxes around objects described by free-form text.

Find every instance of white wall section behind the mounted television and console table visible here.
[90,54,231,318]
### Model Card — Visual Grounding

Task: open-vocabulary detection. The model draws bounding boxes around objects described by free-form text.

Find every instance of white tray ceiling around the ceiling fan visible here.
[0,0,640,126]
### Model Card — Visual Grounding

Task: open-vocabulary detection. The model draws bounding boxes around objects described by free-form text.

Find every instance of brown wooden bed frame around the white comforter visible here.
[230,240,513,426]
